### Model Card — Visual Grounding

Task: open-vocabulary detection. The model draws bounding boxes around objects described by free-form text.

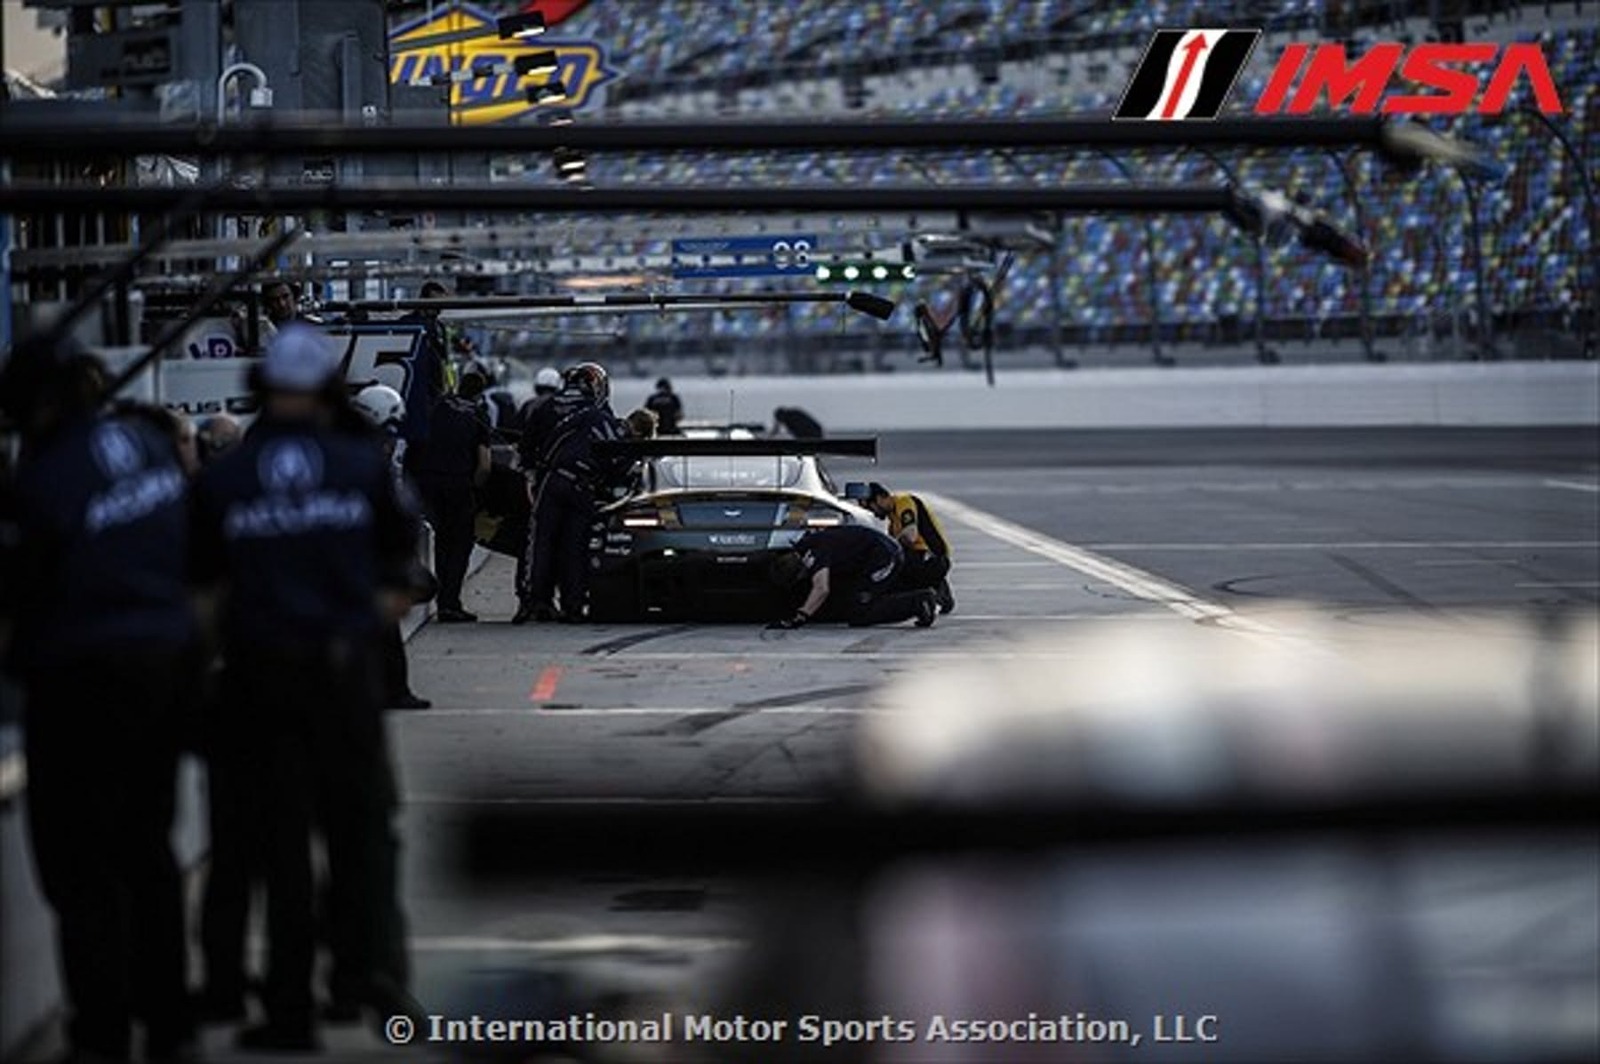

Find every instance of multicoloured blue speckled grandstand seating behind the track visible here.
[547,0,1600,356]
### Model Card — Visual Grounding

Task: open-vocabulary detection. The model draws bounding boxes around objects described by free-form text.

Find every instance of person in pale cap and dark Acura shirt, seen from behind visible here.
[192,325,418,1051]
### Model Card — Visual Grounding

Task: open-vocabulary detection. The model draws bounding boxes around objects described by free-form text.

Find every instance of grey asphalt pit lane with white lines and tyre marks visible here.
[193,429,1600,1059]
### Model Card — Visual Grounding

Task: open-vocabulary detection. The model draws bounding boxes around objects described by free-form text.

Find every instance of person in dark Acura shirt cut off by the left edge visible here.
[0,342,195,1061]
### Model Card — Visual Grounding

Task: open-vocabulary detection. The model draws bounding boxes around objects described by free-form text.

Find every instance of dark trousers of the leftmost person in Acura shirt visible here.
[26,651,192,1058]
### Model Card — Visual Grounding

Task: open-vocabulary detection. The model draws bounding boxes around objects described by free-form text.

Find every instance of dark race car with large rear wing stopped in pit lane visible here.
[589,438,877,621]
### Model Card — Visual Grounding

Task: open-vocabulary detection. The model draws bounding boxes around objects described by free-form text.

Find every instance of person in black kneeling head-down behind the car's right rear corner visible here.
[766,525,938,629]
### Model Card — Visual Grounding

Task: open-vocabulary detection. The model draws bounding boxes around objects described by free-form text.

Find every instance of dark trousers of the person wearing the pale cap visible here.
[219,642,398,1027]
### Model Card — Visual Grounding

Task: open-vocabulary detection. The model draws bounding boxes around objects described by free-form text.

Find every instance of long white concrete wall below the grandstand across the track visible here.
[613,362,1600,432]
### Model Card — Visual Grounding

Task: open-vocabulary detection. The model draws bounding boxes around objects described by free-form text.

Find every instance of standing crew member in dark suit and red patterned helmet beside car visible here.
[512,362,627,624]
